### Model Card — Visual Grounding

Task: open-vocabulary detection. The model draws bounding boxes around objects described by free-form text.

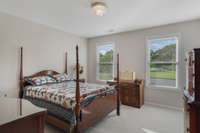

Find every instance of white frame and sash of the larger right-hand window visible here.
[146,34,180,90]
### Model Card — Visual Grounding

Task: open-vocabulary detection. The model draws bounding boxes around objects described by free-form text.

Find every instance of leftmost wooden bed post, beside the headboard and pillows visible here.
[19,47,23,98]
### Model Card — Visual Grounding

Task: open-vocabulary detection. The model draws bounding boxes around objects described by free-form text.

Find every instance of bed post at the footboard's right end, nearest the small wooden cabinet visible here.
[117,54,120,116]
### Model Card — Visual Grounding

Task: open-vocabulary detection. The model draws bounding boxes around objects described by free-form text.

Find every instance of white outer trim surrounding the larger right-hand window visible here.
[146,33,180,90]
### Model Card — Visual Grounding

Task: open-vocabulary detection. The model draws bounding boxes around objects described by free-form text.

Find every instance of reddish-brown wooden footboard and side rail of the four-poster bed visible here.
[46,93,117,133]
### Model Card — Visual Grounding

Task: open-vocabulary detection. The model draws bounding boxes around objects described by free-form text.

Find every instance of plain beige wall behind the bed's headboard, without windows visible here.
[0,13,87,97]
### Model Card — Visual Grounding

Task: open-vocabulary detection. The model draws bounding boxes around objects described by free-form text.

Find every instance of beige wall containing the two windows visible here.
[88,20,200,108]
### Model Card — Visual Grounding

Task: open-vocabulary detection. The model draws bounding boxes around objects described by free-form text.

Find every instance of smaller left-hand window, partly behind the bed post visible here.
[97,44,114,81]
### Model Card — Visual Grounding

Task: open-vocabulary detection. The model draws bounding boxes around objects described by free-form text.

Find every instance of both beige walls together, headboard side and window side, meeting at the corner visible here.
[0,10,200,108]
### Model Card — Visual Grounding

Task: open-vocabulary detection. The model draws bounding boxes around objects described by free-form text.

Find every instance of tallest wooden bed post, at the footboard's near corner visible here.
[75,45,81,133]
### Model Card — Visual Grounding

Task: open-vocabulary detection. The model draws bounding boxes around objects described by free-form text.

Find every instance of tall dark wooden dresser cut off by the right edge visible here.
[184,48,200,133]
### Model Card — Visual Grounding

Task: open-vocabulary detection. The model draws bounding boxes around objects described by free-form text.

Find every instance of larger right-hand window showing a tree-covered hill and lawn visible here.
[147,37,178,88]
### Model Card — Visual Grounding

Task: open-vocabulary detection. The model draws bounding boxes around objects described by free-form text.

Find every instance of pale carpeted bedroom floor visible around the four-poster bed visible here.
[45,105,184,133]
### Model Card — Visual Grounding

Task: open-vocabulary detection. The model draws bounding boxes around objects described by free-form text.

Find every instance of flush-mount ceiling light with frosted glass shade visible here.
[91,2,107,16]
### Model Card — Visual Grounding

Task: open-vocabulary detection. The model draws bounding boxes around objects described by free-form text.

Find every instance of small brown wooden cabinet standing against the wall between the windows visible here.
[120,80,144,108]
